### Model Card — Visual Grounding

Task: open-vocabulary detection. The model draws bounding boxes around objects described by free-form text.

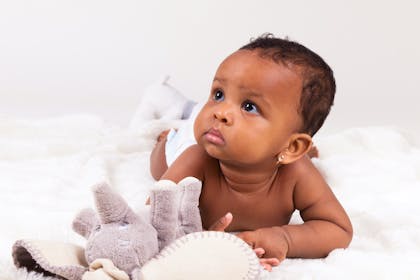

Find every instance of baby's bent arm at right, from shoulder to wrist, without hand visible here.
[282,158,353,258]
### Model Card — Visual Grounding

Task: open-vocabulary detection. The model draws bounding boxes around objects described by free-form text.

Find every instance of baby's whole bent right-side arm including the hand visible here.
[233,158,353,261]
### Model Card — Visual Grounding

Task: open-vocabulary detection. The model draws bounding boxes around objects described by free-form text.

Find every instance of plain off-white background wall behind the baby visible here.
[0,0,420,136]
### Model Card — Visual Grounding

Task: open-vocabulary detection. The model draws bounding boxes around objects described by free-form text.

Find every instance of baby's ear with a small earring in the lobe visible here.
[278,133,312,164]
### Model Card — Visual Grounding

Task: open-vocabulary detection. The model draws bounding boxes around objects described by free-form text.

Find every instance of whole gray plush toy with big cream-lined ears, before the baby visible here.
[12,177,266,280]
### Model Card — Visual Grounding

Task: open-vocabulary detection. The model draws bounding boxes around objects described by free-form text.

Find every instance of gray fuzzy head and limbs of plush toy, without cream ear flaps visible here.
[73,177,202,279]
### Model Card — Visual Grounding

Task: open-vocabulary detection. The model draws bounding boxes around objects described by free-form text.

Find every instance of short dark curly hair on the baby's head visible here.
[240,33,336,136]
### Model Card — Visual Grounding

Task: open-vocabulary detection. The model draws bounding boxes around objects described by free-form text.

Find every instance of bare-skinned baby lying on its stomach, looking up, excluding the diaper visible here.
[151,35,353,269]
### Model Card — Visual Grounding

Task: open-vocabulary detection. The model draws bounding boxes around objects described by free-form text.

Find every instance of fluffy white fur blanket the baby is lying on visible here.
[0,116,420,280]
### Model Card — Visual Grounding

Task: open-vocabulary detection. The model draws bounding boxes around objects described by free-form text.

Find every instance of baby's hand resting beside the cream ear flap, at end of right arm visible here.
[236,227,289,263]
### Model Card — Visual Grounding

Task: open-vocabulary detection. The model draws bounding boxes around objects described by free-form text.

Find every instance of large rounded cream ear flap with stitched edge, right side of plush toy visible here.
[141,231,266,280]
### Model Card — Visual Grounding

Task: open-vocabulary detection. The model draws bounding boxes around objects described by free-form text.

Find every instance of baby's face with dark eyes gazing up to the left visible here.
[194,50,302,164]
